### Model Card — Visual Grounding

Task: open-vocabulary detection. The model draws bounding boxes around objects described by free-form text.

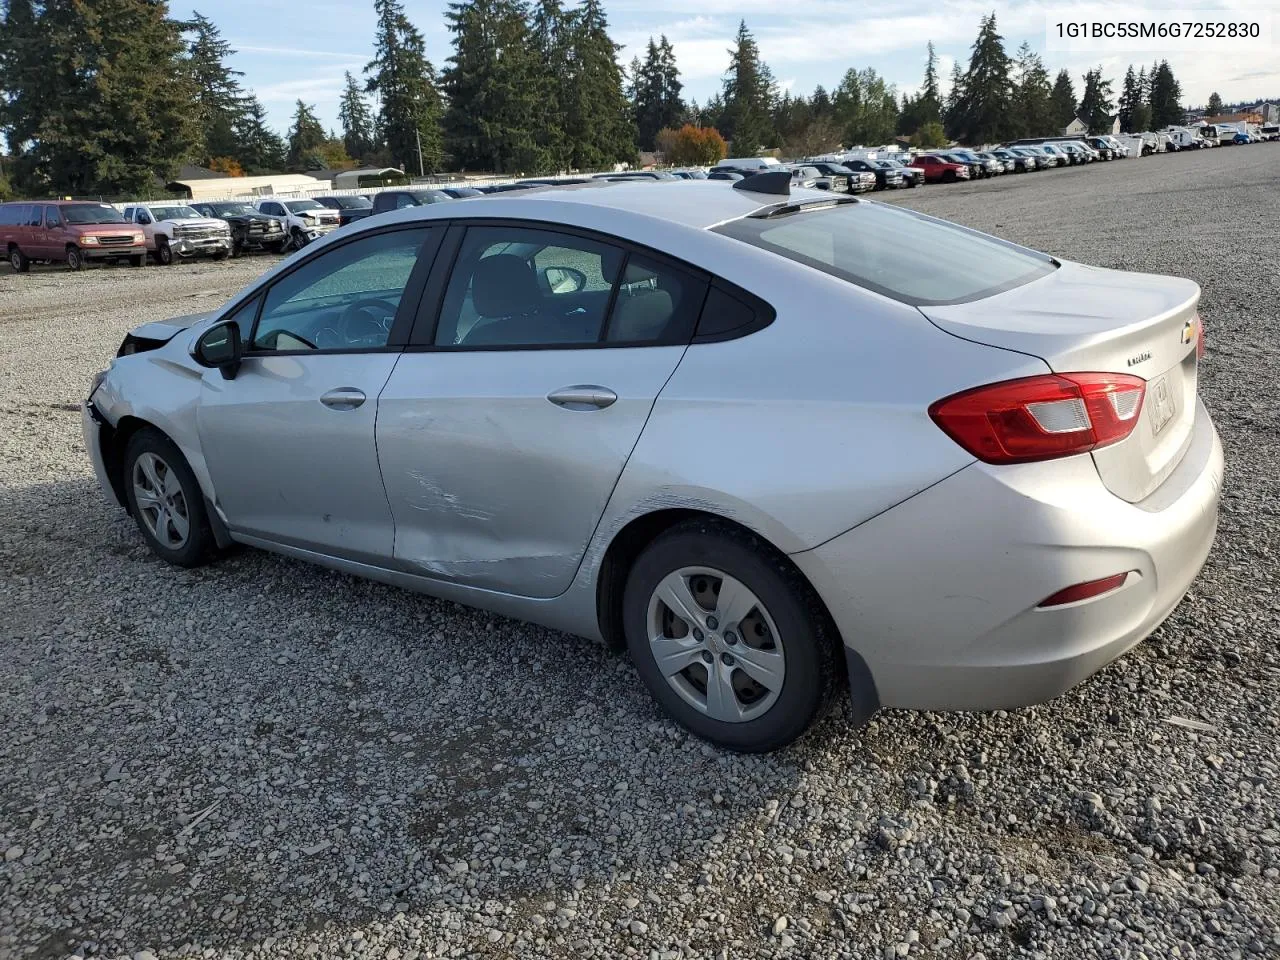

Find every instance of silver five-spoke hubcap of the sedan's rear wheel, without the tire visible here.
[646,567,786,723]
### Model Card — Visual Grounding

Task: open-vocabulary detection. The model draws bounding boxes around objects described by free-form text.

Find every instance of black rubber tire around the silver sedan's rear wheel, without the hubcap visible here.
[622,520,842,753]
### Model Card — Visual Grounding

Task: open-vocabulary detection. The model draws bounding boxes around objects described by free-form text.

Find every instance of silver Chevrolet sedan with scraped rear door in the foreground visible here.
[83,173,1222,751]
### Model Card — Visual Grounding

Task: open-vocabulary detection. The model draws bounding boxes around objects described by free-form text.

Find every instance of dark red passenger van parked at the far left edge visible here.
[0,200,147,274]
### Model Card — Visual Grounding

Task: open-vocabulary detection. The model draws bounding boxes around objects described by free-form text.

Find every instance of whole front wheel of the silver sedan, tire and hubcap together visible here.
[124,428,215,567]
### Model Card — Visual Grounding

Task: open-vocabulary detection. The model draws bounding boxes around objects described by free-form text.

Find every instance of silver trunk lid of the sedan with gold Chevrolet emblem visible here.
[920,262,1201,503]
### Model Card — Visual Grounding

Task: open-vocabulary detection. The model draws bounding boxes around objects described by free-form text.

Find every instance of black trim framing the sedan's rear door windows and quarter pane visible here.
[404,216,777,353]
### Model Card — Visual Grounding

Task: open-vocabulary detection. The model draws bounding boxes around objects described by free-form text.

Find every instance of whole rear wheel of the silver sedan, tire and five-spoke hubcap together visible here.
[622,520,840,753]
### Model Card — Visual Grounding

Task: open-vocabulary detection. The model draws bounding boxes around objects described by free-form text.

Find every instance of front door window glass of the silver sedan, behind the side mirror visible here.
[252,229,429,351]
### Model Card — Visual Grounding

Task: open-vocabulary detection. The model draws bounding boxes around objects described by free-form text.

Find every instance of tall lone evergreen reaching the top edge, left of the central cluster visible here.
[365,0,444,173]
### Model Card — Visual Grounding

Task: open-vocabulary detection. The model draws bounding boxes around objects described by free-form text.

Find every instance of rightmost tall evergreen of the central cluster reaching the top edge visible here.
[564,0,636,170]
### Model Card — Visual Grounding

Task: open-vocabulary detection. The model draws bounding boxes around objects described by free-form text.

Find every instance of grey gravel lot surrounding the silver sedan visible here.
[0,145,1280,960]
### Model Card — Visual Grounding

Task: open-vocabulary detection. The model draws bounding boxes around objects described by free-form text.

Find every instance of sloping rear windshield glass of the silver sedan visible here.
[714,202,1057,306]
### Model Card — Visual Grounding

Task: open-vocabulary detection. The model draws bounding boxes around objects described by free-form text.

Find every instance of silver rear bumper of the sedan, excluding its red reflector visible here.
[792,403,1222,709]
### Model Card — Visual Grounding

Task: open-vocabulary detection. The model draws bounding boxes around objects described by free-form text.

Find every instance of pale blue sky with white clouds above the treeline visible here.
[172,0,1280,131]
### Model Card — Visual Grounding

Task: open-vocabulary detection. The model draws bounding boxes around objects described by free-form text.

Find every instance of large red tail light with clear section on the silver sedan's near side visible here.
[929,374,1147,463]
